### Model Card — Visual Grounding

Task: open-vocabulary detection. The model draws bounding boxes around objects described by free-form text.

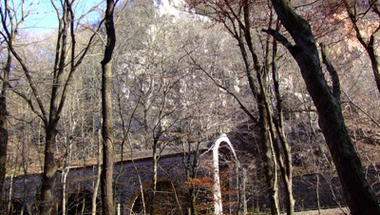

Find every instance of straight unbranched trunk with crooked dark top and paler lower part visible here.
[101,0,116,215]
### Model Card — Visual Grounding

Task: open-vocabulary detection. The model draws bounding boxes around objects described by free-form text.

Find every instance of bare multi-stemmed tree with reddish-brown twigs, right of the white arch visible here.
[186,0,294,214]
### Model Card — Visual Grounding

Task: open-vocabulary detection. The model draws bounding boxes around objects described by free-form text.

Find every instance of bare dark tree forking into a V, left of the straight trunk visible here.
[2,0,100,214]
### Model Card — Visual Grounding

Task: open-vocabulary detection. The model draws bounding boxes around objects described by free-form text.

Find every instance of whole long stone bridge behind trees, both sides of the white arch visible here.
[6,135,380,215]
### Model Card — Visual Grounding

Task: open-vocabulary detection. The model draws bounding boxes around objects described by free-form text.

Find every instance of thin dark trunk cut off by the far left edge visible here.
[0,50,12,204]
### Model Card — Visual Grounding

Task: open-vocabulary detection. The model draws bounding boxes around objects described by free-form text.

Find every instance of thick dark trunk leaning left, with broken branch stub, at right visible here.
[272,0,380,215]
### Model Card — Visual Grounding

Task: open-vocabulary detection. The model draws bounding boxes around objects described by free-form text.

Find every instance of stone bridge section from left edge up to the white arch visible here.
[6,135,236,215]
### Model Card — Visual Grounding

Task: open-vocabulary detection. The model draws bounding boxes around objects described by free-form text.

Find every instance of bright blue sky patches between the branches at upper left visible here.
[9,0,103,33]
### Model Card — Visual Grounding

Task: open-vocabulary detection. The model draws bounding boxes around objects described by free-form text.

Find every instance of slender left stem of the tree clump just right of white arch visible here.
[238,3,280,215]
